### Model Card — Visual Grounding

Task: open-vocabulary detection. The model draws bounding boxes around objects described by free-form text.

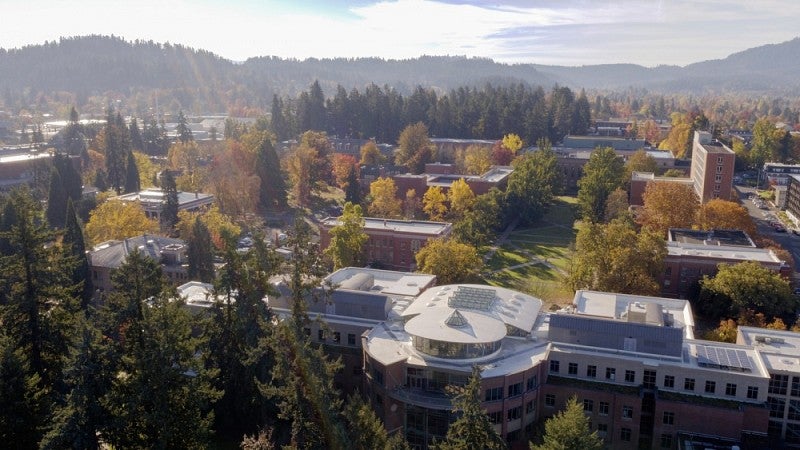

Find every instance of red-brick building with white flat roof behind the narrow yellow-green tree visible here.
[319,217,453,271]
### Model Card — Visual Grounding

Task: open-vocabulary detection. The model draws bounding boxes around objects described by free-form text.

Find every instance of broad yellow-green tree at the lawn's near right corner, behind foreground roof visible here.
[569,219,667,295]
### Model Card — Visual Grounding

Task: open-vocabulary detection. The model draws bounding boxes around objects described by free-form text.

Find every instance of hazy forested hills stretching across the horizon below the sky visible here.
[0,36,800,110]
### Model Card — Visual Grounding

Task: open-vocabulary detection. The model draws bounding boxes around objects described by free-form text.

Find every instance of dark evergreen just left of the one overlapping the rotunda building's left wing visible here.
[204,231,283,439]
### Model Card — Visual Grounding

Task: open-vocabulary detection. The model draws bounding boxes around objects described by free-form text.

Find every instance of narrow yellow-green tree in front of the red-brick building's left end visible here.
[325,202,369,270]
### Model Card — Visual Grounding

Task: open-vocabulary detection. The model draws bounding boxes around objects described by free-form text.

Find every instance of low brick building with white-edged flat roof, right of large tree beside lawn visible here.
[661,228,791,298]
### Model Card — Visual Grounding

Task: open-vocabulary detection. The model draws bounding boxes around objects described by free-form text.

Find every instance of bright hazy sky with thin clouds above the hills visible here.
[0,0,800,66]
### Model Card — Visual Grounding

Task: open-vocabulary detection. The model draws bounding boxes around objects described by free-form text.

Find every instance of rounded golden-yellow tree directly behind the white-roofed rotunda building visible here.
[416,239,483,284]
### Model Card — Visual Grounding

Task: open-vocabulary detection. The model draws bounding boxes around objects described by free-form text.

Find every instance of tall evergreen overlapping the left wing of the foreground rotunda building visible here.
[264,219,349,450]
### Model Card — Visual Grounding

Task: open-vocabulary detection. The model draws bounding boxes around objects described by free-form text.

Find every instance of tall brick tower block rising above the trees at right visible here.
[691,131,736,203]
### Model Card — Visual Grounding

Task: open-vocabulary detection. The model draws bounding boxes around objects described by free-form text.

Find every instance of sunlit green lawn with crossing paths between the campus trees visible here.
[485,197,577,307]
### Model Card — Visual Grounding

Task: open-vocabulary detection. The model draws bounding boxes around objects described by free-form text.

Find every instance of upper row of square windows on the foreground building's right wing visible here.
[550,360,756,399]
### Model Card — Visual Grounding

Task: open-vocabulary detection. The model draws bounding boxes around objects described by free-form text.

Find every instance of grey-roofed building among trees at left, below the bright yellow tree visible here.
[88,234,189,295]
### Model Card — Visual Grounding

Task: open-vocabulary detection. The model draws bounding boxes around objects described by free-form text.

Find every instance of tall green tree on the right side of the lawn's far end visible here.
[578,147,625,222]
